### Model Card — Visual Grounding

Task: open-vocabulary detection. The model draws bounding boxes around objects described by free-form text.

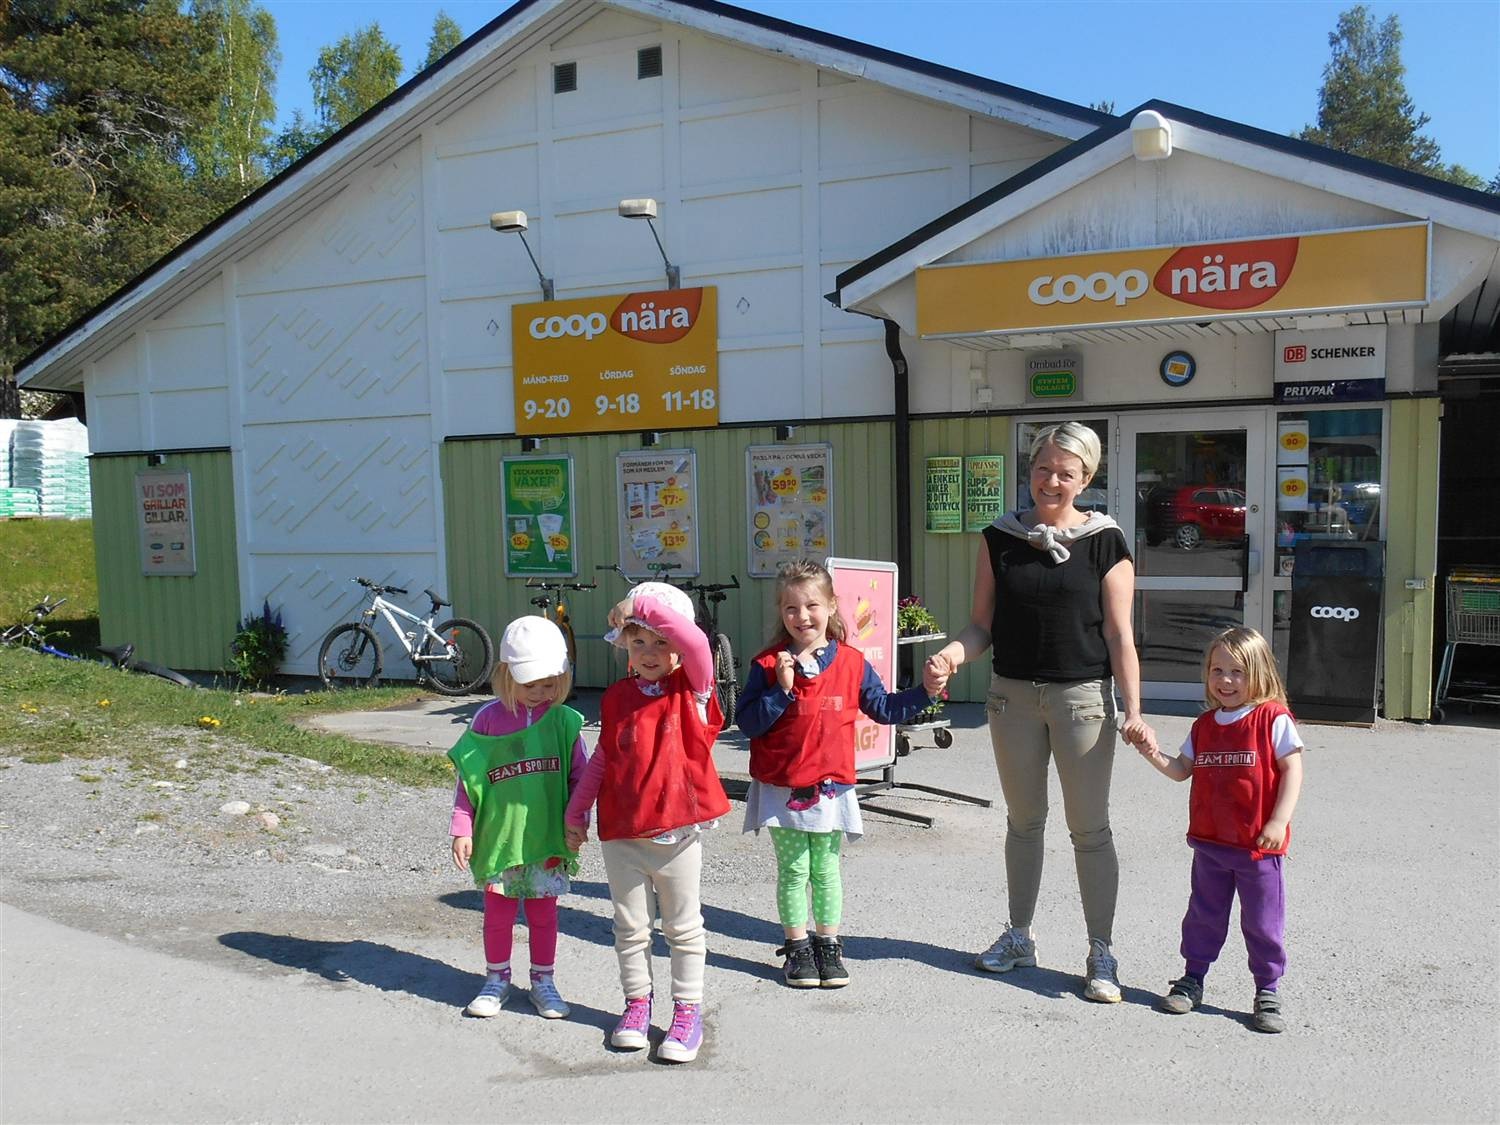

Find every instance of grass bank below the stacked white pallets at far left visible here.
[0,519,99,653]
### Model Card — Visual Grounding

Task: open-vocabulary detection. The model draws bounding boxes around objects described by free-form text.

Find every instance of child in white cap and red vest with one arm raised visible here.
[567,582,729,1062]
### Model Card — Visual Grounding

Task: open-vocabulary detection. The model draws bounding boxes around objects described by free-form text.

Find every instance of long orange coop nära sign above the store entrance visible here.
[917,222,1431,336]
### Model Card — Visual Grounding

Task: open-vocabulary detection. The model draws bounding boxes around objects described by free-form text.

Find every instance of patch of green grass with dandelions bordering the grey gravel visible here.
[0,648,453,786]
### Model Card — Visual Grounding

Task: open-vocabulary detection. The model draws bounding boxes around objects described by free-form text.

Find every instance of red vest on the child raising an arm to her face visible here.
[596,668,729,840]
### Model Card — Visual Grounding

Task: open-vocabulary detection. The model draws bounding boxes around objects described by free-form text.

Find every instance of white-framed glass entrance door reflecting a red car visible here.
[1112,411,1266,699]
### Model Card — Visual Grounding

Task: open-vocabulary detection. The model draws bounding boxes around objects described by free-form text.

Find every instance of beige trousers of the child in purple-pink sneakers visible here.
[599,830,708,1004]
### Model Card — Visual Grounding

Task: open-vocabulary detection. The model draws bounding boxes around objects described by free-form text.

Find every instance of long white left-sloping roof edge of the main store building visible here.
[17,0,587,387]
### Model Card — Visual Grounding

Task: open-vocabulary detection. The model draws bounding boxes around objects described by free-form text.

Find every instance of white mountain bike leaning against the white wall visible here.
[318,578,495,696]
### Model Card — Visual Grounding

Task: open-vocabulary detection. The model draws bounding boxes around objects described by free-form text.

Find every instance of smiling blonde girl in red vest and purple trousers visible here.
[1136,629,1304,1032]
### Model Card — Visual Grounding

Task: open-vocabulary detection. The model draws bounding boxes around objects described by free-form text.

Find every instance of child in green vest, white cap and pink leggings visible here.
[449,617,587,1020]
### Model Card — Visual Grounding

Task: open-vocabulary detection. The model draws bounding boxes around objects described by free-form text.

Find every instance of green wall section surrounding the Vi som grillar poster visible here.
[90,452,240,671]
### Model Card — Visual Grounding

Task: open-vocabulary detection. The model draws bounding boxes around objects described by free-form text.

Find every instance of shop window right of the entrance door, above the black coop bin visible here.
[1277,410,1382,576]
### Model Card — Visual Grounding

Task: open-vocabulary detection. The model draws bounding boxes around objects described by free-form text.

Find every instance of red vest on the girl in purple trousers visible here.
[1188,701,1292,860]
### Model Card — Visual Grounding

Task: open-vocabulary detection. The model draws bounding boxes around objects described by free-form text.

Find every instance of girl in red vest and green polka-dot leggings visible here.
[735,560,948,989]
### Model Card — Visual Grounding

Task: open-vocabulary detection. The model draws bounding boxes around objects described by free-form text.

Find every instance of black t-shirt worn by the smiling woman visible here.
[984,527,1130,684]
